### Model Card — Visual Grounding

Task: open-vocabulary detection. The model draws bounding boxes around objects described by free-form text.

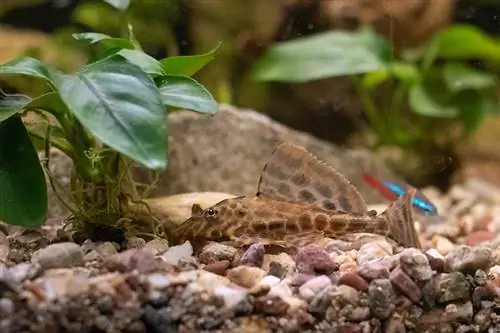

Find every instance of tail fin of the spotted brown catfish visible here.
[378,188,421,249]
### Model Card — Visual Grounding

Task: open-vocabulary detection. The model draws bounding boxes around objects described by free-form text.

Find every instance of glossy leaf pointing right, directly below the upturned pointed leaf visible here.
[159,75,217,114]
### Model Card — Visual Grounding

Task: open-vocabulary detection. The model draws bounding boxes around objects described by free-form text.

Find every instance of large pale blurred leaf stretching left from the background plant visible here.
[252,30,390,83]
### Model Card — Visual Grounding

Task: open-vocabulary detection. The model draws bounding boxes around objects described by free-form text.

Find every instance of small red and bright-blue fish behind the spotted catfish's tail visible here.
[363,174,437,215]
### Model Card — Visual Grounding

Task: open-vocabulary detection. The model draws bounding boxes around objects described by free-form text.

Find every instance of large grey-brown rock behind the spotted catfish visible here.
[49,105,392,219]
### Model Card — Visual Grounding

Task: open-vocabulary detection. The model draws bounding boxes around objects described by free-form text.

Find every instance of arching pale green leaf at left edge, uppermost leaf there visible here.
[0,57,53,86]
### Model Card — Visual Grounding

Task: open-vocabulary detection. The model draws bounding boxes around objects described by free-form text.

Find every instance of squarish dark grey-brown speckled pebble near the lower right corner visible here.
[435,272,470,303]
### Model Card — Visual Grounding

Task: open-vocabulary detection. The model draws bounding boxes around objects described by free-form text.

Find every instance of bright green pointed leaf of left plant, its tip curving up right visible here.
[160,42,222,76]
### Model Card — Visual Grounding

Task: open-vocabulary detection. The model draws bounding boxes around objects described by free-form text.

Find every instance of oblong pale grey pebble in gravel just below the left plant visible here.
[31,242,84,270]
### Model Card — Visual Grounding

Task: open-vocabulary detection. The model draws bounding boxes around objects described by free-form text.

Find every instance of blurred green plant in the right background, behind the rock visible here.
[252,25,500,179]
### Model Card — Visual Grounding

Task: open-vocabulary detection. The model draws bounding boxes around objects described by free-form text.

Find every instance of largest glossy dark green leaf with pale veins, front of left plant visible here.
[57,57,167,170]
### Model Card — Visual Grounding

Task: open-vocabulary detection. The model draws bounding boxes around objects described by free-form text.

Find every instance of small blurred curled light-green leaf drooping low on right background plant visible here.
[409,81,458,118]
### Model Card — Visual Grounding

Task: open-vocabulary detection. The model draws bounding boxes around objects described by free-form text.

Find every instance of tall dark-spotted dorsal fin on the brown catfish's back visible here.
[257,143,367,214]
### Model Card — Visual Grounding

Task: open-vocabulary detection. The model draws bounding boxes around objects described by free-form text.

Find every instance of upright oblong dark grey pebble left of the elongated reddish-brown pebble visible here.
[368,279,395,319]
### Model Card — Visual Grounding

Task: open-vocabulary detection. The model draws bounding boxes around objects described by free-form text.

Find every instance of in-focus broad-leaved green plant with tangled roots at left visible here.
[0,0,217,236]
